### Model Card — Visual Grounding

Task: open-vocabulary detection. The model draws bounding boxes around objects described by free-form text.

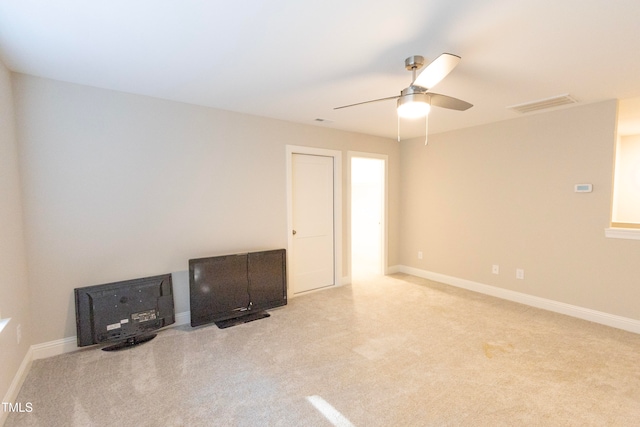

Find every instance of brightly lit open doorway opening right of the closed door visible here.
[350,153,386,278]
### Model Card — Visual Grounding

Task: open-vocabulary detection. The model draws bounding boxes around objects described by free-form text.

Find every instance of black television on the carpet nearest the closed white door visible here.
[189,249,287,328]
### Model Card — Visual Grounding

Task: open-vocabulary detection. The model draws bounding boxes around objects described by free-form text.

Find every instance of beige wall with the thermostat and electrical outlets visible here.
[400,101,640,319]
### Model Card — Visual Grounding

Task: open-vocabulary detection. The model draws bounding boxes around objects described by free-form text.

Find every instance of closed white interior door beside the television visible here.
[290,154,335,293]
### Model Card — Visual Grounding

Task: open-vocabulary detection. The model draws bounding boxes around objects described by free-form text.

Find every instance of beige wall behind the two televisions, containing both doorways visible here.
[15,75,399,343]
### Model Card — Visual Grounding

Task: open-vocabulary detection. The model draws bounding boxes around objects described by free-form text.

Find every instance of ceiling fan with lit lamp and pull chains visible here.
[334,53,473,141]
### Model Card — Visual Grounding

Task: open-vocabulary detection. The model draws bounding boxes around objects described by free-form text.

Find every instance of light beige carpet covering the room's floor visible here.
[6,275,640,426]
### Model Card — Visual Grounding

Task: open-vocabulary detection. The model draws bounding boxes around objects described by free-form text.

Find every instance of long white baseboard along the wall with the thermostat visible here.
[396,265,640,334]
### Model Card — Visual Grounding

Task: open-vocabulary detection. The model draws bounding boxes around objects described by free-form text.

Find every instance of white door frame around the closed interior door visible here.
[286,145,343,298]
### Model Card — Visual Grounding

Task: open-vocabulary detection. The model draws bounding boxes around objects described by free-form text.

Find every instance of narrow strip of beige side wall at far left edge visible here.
[0,63,32,404]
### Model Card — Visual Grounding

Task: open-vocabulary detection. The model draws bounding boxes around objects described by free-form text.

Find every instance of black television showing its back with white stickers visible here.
[74,274,175,351]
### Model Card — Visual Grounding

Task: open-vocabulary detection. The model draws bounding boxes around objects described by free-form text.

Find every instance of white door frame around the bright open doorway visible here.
[347,151,389,283]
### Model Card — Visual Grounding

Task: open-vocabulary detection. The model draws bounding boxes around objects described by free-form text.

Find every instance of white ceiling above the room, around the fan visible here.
[0,0,640,138]
